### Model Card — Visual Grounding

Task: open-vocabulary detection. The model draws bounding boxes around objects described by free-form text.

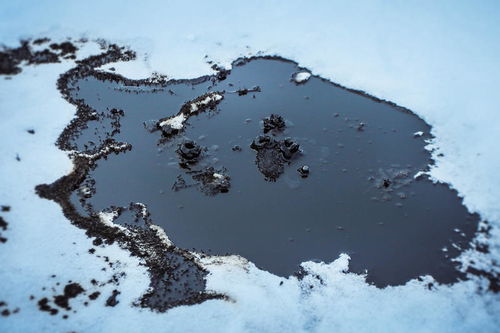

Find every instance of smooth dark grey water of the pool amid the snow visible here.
[66,59,477,286]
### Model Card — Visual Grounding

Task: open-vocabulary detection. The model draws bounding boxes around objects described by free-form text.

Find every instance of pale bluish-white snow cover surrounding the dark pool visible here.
[0,1,500,332]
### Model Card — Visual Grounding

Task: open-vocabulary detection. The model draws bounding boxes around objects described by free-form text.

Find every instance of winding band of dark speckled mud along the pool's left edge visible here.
[36,42,224,313]
